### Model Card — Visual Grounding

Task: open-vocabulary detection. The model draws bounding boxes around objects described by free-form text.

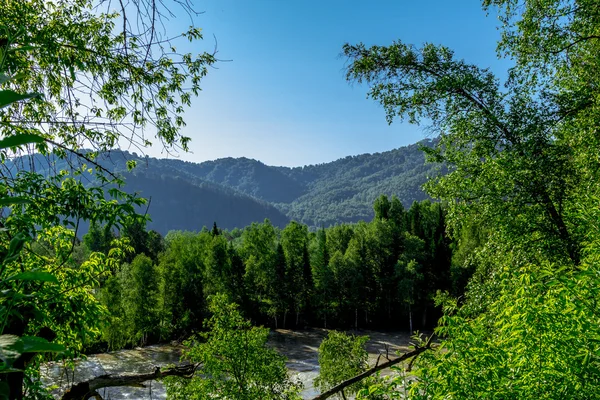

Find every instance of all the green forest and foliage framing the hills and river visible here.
[0,0,600,400]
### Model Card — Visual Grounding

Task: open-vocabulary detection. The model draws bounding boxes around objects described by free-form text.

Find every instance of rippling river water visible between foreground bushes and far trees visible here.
[42,329,410,400]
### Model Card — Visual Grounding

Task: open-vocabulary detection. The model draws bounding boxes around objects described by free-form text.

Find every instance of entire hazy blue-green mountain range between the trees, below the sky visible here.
[7,140,439,234]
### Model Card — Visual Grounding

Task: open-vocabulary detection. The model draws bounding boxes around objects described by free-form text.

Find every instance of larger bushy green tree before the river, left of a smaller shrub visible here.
[165,295,299,400]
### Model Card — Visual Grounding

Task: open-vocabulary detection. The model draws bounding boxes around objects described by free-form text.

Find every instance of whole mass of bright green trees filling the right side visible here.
[344,0,600,399]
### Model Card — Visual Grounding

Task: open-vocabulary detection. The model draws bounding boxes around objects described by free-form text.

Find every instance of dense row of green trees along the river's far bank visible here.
[80,195,462,349]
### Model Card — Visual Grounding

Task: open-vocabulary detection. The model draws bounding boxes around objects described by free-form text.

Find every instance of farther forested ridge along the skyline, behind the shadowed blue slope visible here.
[104,140,439,229]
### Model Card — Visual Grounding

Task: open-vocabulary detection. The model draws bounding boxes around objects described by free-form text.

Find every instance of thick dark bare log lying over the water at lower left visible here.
[61,364,198,400]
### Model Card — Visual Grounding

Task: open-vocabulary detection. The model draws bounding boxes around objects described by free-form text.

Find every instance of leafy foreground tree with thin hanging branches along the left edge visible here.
[0,0,214,399]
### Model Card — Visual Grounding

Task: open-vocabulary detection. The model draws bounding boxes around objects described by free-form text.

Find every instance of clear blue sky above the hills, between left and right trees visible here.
[147,0,508,166]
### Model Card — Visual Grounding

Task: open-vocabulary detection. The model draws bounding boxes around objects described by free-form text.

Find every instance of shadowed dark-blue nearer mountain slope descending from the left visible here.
[5,151,289,235]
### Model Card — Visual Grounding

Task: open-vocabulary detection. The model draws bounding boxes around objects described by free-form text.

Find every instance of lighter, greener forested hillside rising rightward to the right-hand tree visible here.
[277,139,439,227]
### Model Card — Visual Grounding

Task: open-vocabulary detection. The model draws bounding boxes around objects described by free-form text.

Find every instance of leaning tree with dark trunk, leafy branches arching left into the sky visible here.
[344,42,579,262]
